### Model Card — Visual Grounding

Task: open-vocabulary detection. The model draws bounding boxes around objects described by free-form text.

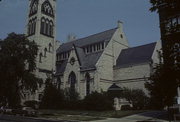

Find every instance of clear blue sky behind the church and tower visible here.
[0,0,160,47]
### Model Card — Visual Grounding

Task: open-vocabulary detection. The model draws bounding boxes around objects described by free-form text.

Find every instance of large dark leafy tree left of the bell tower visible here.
[0,33,42,107]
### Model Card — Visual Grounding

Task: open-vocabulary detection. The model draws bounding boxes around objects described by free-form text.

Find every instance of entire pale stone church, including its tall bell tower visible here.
[24,0,161,101]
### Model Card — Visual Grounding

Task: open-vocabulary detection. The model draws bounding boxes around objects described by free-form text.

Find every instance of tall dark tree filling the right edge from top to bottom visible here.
[148,0,180,108]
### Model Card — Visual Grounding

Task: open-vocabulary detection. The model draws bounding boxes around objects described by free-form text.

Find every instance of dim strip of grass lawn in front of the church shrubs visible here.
[39,110,145,121]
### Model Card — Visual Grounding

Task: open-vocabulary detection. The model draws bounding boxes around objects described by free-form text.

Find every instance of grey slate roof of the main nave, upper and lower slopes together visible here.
[56,28,117,75]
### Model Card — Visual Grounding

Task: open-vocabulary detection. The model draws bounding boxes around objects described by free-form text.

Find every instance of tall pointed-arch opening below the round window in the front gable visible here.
[69,72,76,92]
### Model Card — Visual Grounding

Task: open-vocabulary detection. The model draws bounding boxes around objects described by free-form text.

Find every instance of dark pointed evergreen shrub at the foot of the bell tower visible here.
[40,78,64,109]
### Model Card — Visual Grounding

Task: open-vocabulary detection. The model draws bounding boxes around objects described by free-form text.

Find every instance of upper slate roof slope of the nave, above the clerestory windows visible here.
[57,28,117,53]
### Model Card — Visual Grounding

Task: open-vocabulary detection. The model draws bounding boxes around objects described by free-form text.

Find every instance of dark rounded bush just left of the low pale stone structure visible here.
[83,91,113,111]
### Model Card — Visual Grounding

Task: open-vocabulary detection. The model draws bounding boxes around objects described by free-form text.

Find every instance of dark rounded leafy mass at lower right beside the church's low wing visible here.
[145,63,180,109]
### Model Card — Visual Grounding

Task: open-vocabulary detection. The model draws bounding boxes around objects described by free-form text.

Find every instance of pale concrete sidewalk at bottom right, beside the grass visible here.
[92,112,169,122]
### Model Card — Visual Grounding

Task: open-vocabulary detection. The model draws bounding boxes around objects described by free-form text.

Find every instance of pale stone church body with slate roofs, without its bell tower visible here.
[56,21,161,98]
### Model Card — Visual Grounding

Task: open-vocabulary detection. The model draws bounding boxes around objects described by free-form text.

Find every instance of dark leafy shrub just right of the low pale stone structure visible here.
[122,88,149,109]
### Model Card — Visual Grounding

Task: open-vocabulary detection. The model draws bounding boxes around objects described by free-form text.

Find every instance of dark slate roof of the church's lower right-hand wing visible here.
[116,42,156,68]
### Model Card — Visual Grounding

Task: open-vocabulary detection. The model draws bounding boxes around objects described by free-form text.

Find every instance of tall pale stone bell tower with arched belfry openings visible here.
[26,0,56,100]
